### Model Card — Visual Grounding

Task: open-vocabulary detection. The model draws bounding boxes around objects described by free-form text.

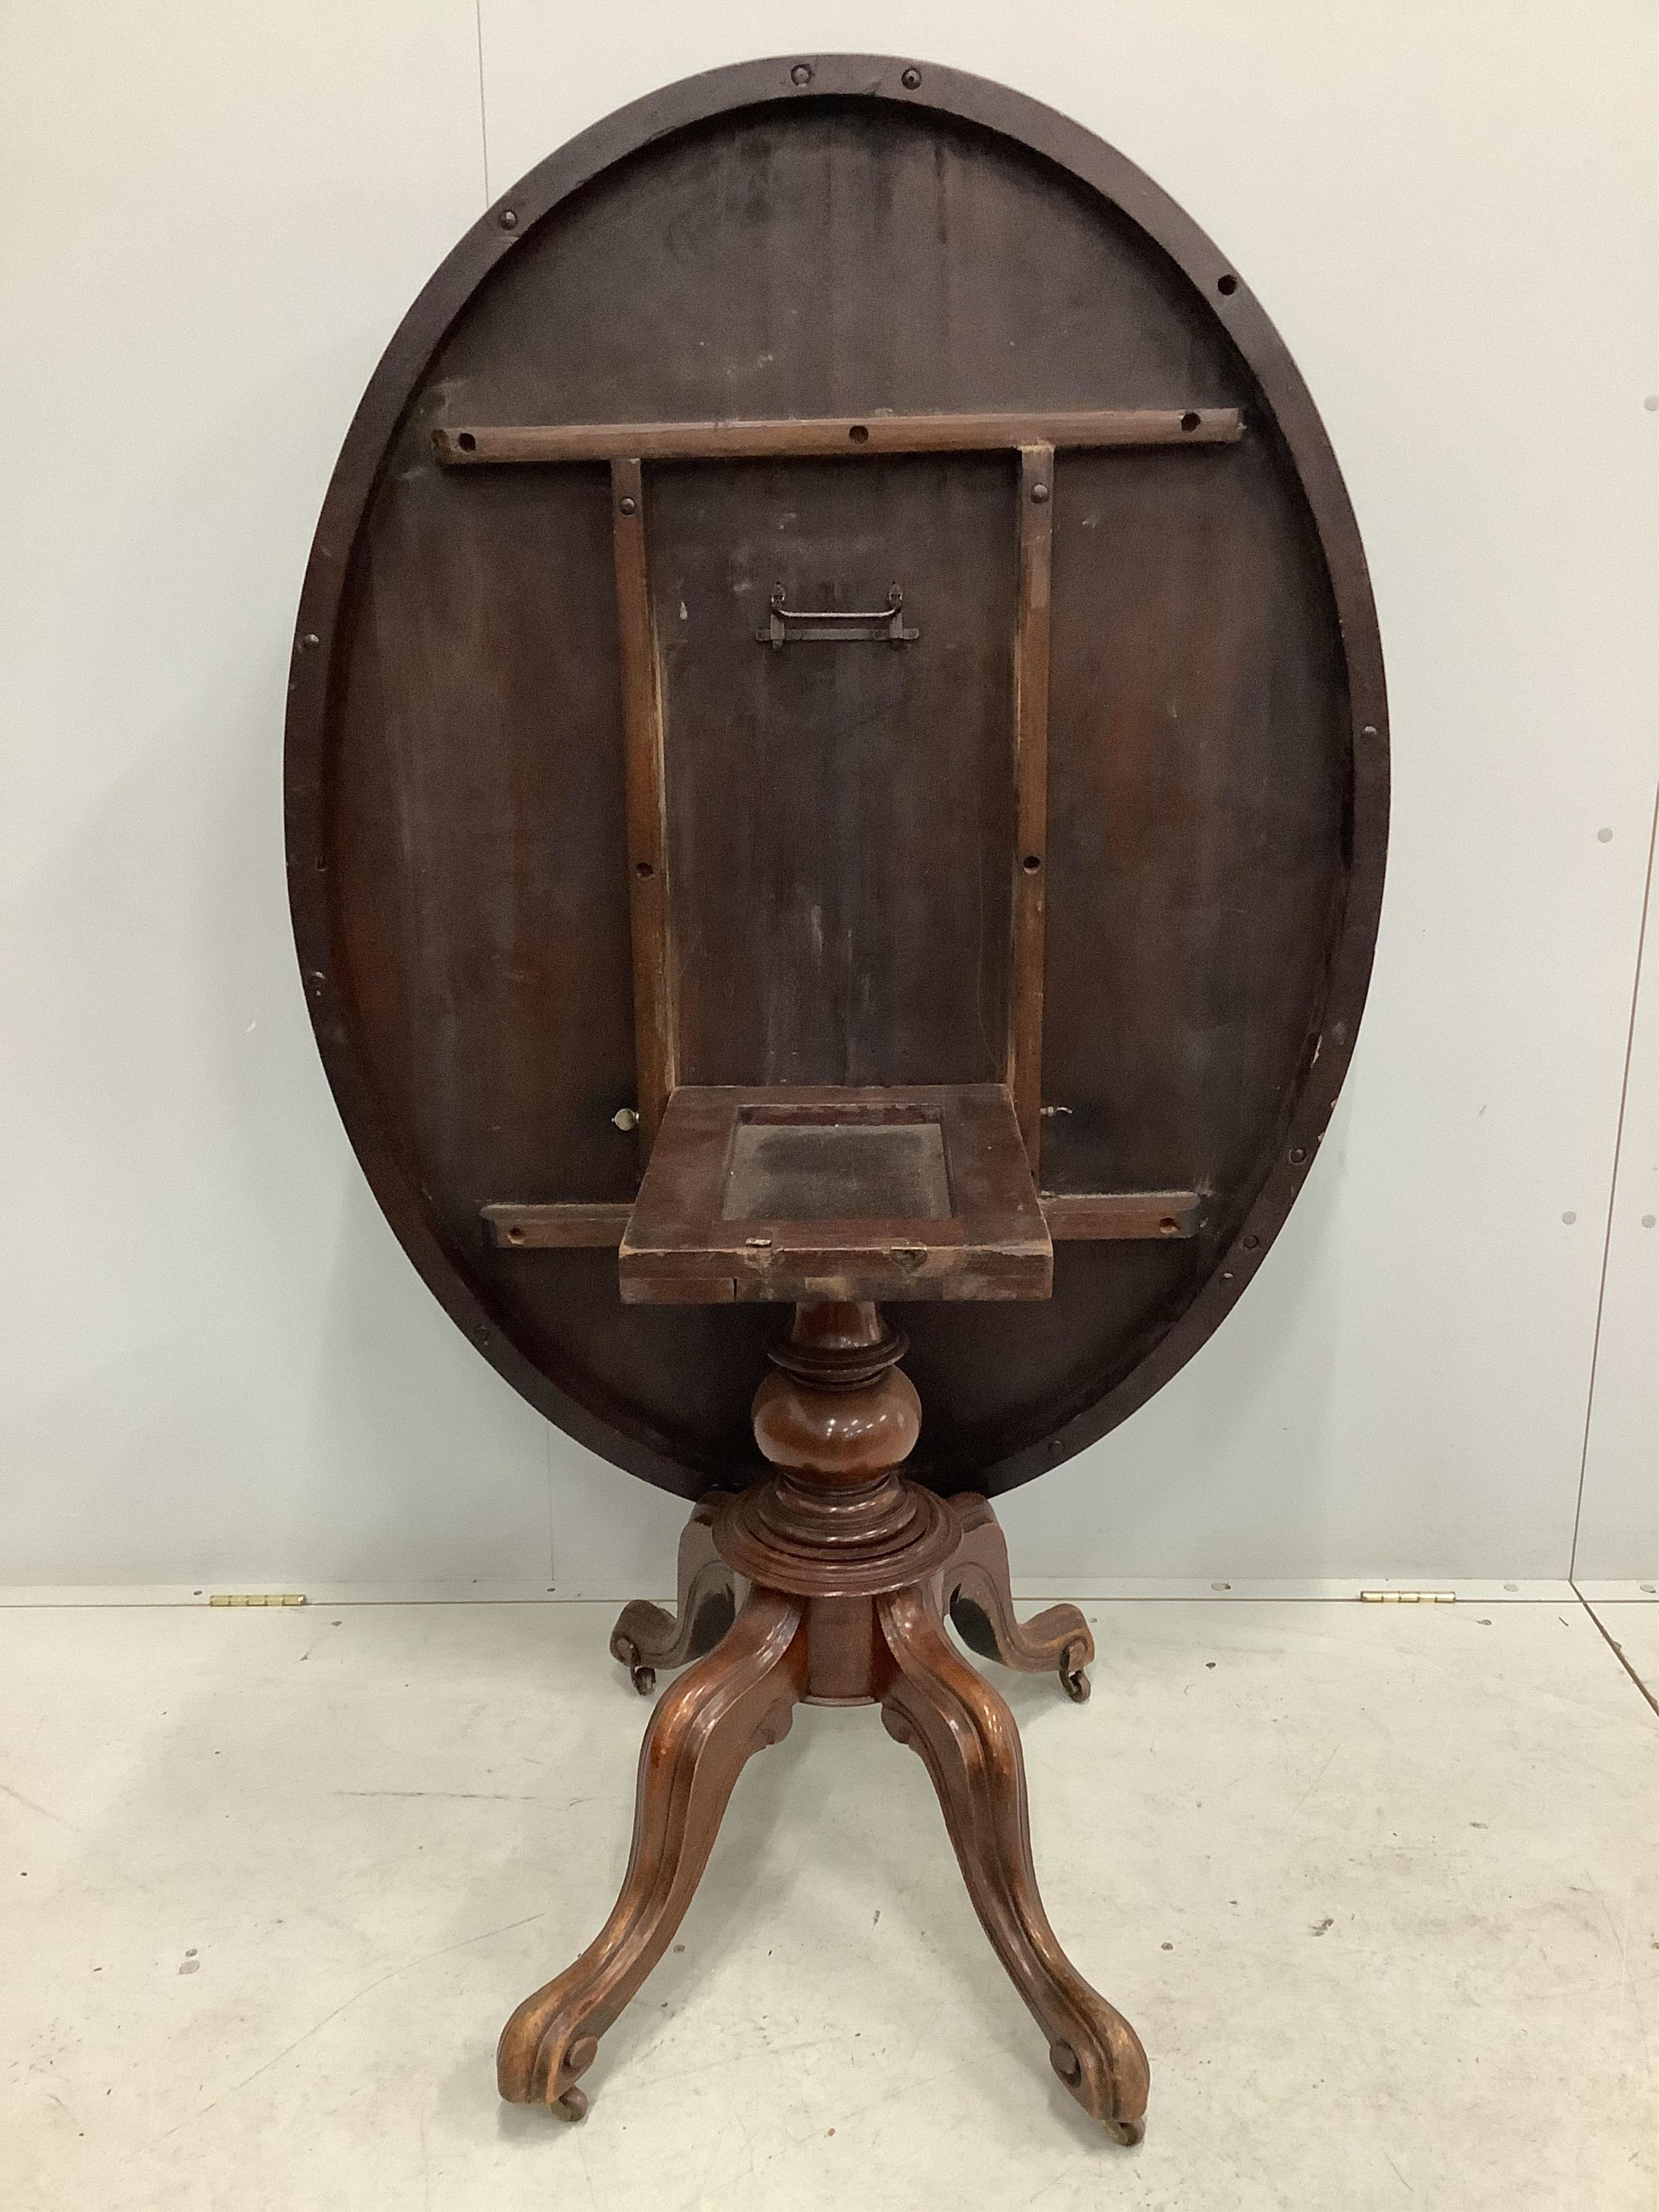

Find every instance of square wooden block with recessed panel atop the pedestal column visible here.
[617,1084,1053,1305]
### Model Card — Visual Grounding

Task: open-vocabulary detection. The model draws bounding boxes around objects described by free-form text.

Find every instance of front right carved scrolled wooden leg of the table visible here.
[876,1577,1148,2143]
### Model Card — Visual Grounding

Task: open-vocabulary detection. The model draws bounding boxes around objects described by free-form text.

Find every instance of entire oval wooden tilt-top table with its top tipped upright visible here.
[287,55,1387,2141]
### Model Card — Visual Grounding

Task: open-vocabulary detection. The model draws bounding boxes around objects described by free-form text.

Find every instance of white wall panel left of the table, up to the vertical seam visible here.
[0,0,559,1582]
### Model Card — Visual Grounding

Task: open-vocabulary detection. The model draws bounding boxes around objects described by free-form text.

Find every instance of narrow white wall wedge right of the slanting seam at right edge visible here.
[1573,818,1659,1582]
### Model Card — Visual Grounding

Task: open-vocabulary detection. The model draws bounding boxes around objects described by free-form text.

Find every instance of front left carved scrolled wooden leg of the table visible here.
[496,1590,805,2119]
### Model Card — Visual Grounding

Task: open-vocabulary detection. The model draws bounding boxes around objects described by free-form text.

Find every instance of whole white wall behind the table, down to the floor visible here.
[0,0,1659,1593]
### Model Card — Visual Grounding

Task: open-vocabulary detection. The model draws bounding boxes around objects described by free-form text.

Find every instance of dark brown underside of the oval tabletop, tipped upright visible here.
[287,57,1387,1498]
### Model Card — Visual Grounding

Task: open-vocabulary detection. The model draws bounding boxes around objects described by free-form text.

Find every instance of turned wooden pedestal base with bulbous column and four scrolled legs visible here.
[498,1303,1148,2141]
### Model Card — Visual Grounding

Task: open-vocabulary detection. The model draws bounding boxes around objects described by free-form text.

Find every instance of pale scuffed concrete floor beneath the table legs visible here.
[0,1602,1659,2212]
